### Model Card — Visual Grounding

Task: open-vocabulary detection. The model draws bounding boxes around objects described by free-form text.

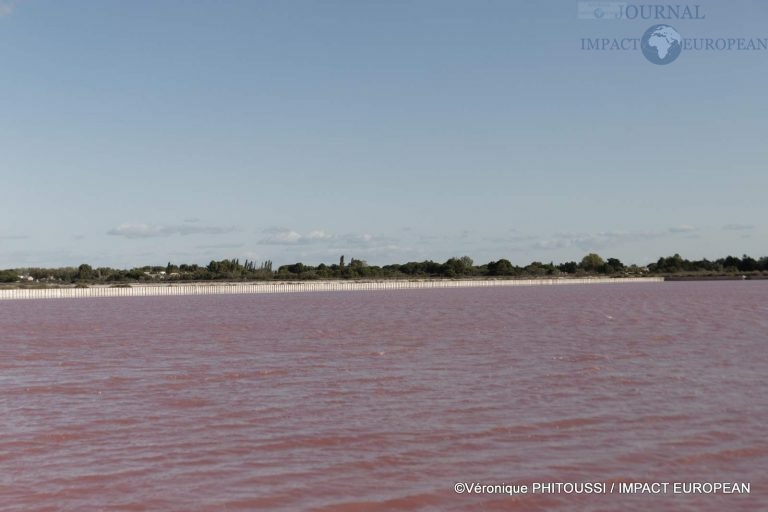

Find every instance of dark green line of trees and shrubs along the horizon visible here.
[0,253,768,284]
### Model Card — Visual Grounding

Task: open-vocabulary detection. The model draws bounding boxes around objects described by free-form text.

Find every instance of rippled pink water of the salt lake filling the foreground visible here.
[0,282,768,511]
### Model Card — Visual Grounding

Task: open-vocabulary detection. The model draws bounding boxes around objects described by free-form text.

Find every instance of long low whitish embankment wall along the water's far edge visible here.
[0,277,664,300]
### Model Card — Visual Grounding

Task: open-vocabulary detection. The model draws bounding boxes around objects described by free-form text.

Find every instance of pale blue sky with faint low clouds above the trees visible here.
[0,0,768,268]
